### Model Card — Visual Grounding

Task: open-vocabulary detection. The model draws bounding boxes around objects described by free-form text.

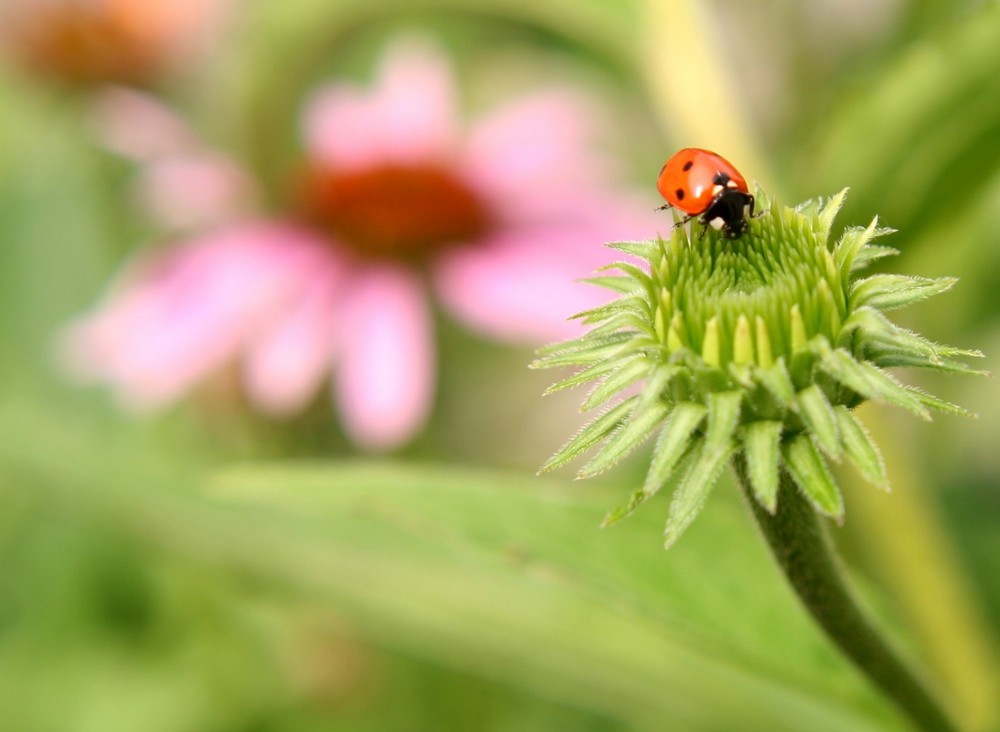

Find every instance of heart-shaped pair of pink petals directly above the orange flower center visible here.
[304,42,456,168]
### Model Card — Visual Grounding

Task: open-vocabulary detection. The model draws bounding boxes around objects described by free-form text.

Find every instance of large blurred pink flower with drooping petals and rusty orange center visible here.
[60,43,662,449]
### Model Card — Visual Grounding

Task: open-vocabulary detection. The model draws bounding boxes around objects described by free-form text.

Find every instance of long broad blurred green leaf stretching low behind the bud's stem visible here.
[0,406,916,730]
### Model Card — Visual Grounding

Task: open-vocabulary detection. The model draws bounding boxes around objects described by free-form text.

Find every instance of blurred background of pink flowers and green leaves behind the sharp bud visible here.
[0,0,1000,732]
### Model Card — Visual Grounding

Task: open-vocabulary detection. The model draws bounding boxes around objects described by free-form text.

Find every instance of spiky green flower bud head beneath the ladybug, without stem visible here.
[534,190,981,545]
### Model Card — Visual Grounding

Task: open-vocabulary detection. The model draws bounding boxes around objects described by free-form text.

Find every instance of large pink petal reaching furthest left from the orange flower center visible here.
[67,224,334,408]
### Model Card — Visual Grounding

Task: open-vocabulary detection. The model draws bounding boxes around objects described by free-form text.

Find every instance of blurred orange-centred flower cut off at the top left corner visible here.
[0,0,222,85]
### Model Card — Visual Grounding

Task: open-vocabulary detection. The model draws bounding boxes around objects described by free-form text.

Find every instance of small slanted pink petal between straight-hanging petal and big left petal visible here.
[244,268,343,416]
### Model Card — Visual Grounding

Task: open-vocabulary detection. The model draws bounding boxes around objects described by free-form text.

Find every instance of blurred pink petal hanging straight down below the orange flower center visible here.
[336,266,434,450]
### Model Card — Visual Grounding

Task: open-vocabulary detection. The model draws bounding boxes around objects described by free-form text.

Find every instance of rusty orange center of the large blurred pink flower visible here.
[302,164,492,259]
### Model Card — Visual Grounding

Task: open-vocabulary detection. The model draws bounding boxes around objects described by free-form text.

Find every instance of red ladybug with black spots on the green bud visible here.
[656,147,754,239]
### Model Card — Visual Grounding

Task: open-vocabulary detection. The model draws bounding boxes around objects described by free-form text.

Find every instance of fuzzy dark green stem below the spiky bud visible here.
[734,455,957,732]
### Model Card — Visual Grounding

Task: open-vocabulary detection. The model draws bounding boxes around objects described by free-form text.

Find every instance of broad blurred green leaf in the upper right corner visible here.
[800,3,1000,235]
